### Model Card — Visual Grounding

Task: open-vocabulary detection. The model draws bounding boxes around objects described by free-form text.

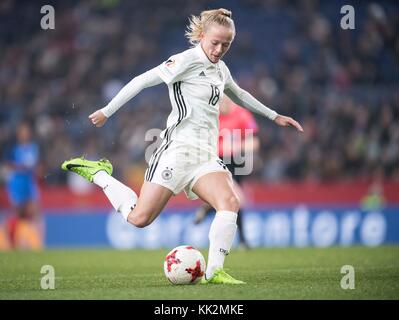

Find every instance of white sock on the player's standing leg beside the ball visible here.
[205,211,237,279]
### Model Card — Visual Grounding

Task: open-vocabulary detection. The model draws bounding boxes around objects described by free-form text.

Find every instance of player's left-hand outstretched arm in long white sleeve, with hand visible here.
[89,68,162,127]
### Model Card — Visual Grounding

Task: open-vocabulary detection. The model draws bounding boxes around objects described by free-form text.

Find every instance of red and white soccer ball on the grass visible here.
[163,245,206,284]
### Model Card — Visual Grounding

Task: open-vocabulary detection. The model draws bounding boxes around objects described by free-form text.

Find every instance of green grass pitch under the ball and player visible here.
[0,246,399,300]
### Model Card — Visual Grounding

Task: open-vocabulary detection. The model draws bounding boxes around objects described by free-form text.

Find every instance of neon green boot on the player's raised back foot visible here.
[61,157,113,182]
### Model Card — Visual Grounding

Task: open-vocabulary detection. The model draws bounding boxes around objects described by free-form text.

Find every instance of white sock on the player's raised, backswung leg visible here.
[93,170,137,221]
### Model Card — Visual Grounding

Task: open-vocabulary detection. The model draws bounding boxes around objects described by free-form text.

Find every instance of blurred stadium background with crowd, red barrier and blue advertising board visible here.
[0,0,399,249]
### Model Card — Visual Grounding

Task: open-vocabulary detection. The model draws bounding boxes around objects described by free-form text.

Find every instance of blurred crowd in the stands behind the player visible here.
[0,0,399,185]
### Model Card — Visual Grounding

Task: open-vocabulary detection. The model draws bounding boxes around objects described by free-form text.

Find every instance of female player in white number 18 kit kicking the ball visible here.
[62,9,303,284]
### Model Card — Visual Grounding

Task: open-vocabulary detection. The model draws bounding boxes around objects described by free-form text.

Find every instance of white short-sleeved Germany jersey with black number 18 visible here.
[156,45,233,153]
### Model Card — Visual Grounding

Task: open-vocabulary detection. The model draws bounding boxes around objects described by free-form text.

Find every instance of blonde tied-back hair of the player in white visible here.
[185,8,236,46]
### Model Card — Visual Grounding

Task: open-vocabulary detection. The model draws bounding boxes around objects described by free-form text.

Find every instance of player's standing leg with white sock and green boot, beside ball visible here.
[193,172,244,284]
